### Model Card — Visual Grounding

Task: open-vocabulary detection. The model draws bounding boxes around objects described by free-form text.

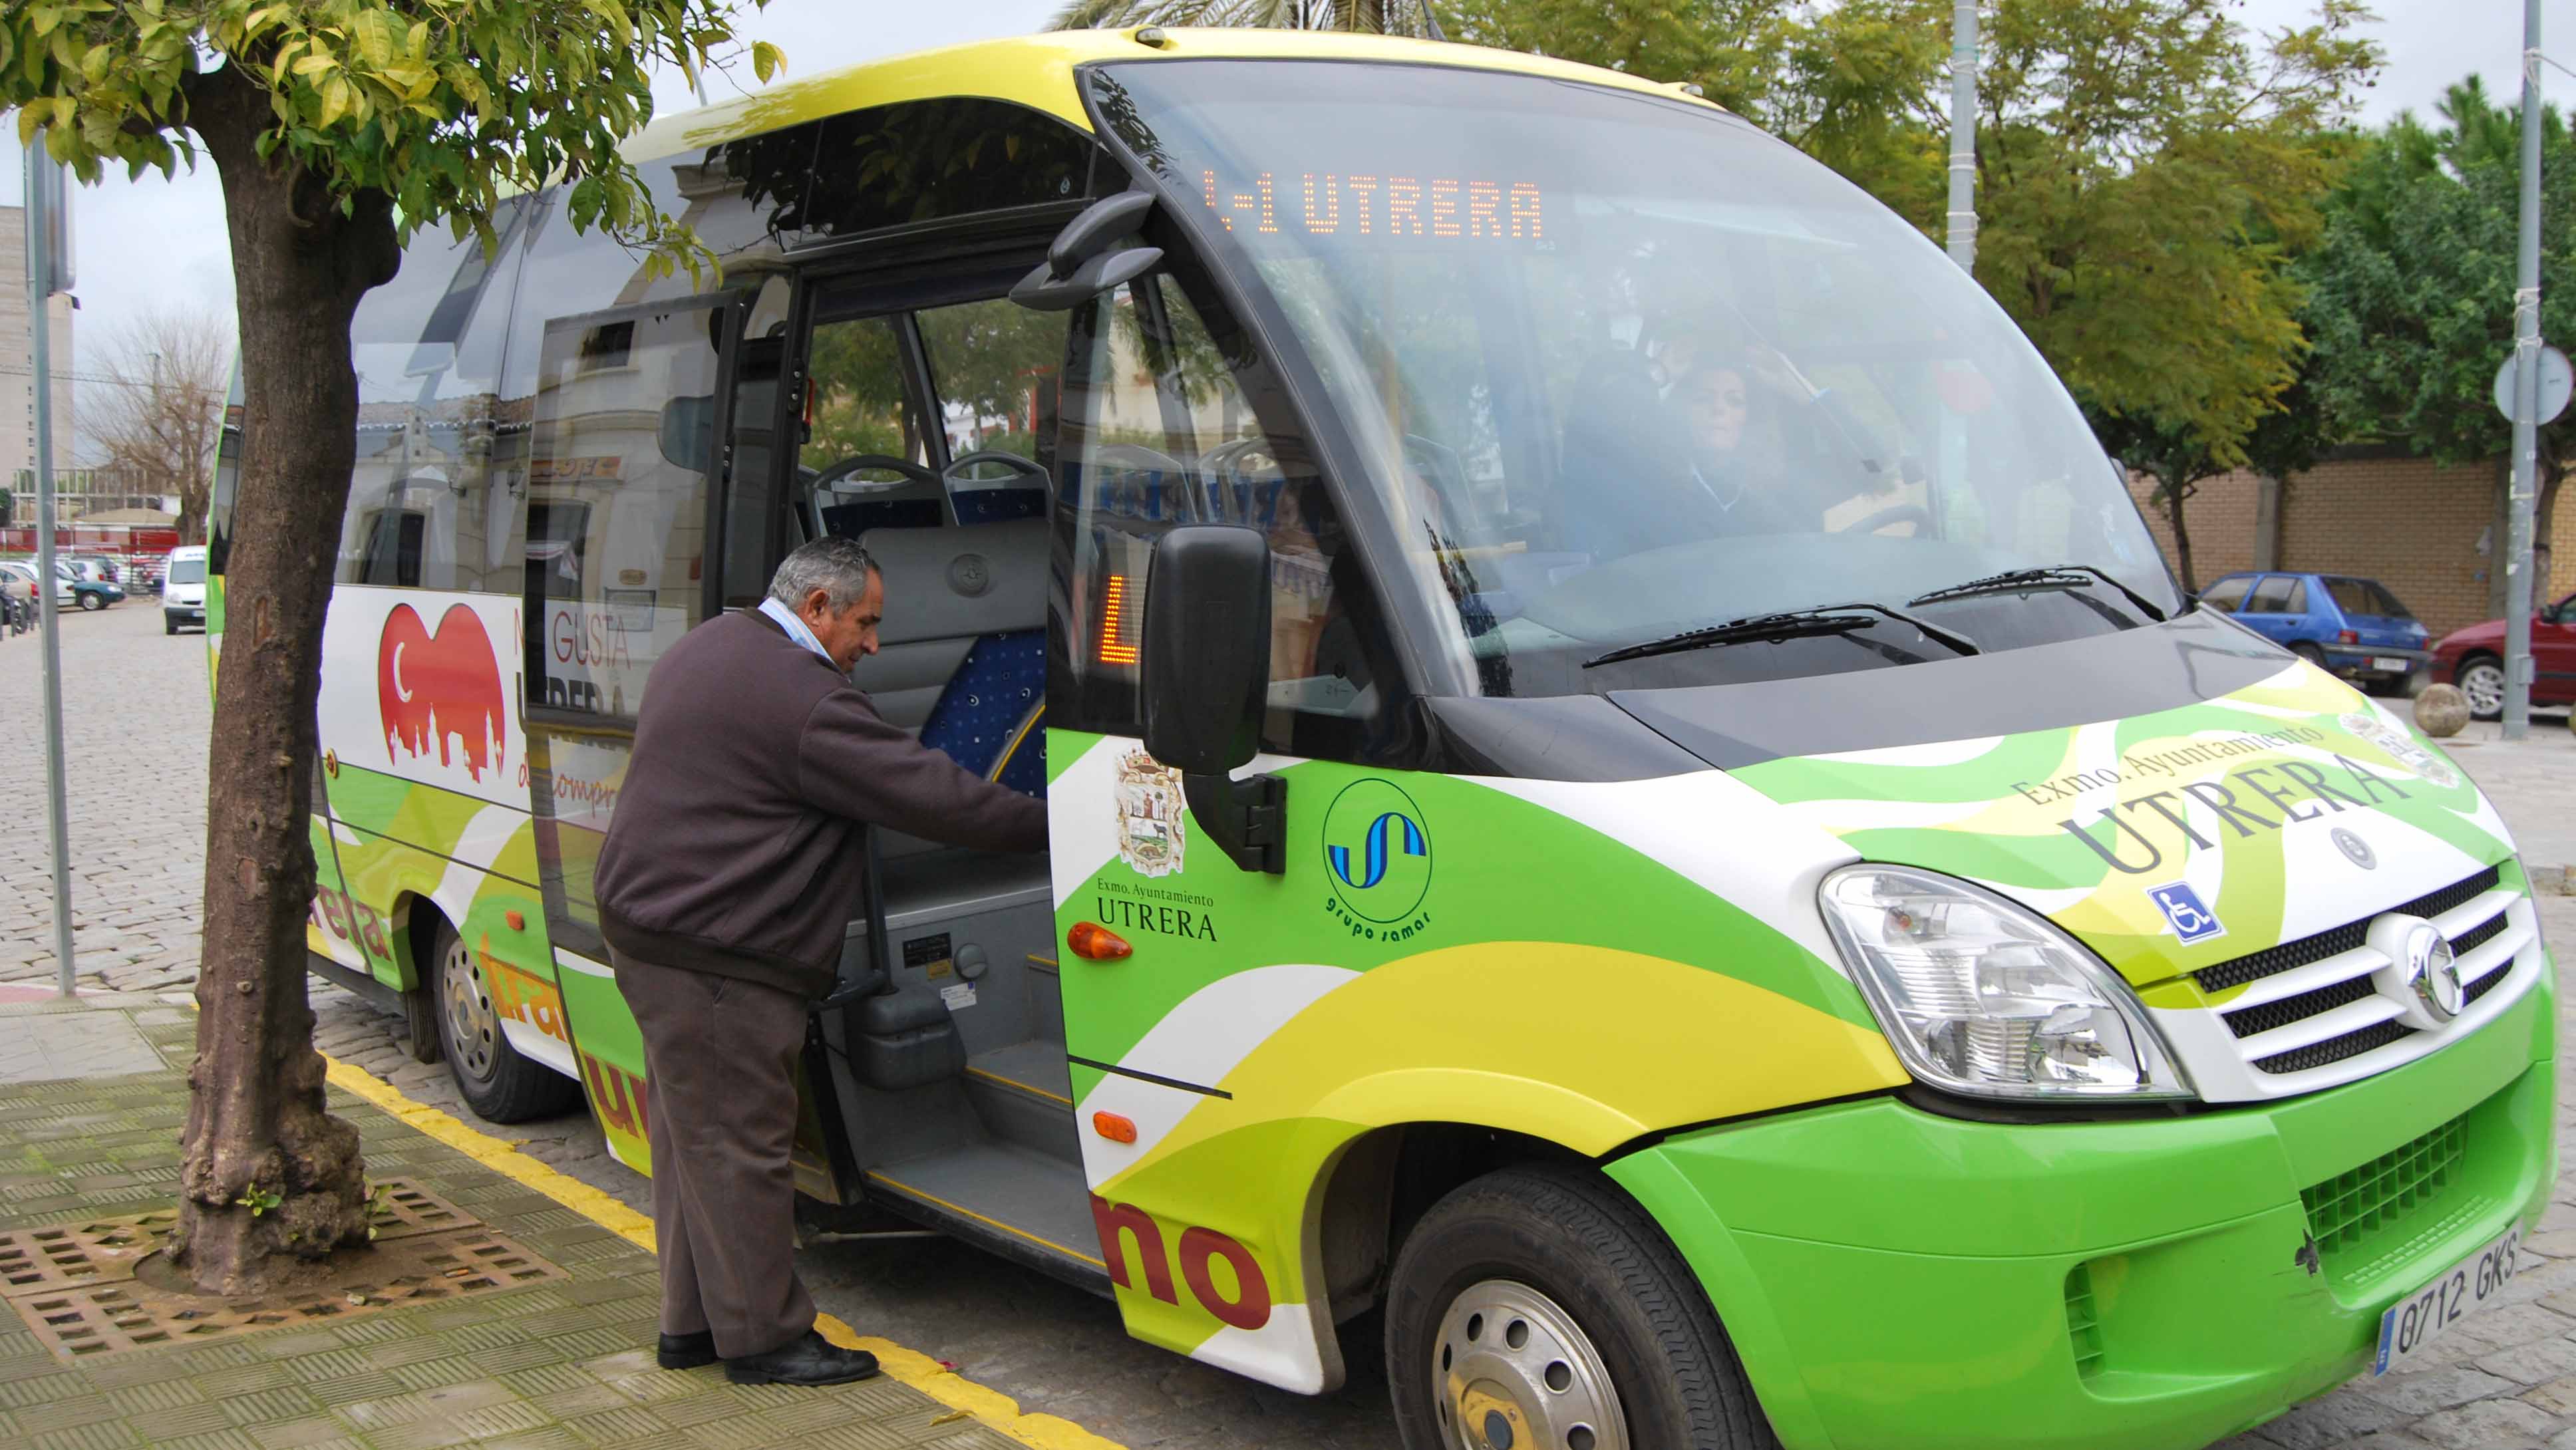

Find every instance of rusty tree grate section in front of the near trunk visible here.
[8,1229,572,1360]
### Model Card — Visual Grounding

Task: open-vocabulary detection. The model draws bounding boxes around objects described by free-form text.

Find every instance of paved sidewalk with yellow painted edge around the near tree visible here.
[0,997,1092,1450]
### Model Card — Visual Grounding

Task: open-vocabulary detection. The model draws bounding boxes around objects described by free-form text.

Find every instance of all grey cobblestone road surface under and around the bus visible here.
[15,600,2576,1450]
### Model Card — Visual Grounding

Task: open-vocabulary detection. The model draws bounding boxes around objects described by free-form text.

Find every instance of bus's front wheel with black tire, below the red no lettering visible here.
[1386,1167,1780,1450]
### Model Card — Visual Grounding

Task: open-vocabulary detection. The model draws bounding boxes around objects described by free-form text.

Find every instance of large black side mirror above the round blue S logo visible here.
[1141,523,1288,873]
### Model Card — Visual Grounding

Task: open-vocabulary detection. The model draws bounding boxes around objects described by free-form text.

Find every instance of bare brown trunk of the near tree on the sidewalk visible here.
[172,67,399,1296]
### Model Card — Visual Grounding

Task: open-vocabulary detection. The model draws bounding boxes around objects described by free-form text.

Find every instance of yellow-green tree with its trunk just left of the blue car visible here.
[1976,0,2378,585]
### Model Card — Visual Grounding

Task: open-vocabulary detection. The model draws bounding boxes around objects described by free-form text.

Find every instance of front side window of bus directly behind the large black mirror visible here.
[1056,275,1370,755]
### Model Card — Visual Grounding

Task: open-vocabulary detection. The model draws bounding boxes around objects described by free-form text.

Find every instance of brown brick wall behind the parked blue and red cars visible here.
[2133,458,2576,639]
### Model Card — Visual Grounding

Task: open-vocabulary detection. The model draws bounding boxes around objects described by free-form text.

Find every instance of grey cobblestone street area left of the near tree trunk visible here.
[0,595,214,992]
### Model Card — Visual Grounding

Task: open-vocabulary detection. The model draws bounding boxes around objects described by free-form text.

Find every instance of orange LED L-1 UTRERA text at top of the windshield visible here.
[1198,170,1545,242]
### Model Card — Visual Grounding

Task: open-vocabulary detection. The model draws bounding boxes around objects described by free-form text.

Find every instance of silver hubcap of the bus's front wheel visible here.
[1432,1280,1628,1450]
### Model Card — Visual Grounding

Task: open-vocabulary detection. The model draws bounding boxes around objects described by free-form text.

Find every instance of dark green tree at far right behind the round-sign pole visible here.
[2301,77,2576,608]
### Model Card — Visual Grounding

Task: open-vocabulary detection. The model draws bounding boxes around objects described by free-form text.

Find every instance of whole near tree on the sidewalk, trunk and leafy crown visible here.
[0,0,778,1293]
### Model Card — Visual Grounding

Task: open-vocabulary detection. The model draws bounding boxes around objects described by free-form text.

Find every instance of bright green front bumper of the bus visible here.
[1607,971,2555,1450]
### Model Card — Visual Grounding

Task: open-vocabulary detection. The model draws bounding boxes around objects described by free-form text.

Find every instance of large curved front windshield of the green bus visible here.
[1092,62,2179,695]
